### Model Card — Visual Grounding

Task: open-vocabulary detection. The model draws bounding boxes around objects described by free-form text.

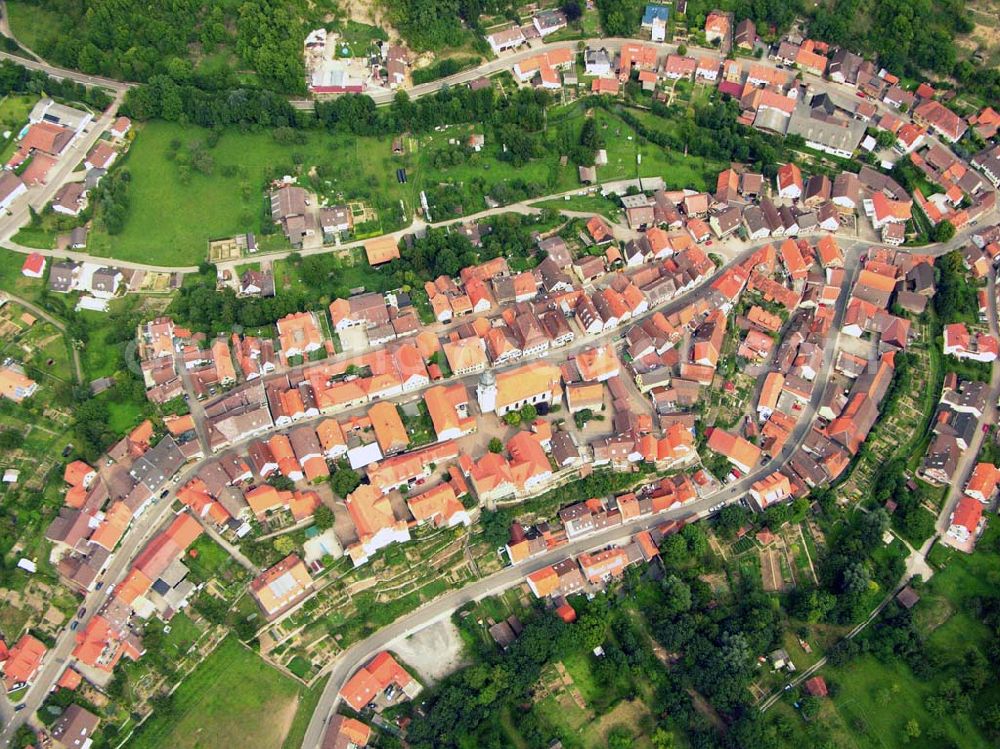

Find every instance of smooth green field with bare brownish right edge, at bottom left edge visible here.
[129,637,307,749]
